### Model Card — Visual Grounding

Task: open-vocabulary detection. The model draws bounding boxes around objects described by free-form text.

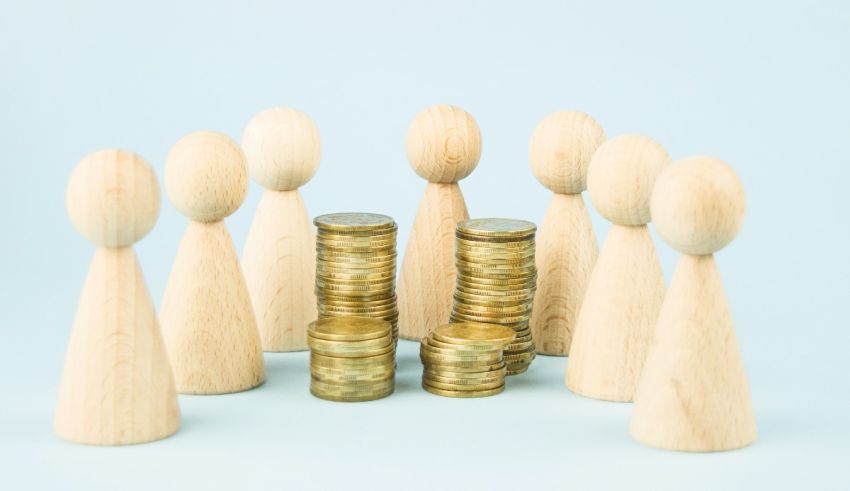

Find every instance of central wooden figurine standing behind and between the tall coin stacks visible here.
[398,106,481,341]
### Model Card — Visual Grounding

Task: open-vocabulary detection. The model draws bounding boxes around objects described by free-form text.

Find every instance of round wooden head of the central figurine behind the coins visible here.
[406,105,481,183]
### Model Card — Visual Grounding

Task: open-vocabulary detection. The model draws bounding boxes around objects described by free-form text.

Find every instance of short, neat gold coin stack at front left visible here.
[307,317,395,402]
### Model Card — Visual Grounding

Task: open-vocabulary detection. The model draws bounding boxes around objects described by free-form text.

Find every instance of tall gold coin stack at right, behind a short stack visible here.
[450,218,537,375]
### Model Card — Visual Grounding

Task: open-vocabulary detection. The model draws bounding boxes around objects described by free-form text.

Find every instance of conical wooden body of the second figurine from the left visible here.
[160,220,265,394]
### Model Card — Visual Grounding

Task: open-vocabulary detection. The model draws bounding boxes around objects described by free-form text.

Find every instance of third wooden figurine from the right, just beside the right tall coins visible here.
[529,111,605,356]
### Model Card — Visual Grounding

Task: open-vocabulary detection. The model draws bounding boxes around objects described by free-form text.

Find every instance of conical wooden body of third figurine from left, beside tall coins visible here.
[242,190,318,351]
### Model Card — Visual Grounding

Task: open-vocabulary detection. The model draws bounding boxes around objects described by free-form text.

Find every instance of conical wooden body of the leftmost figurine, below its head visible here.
[55,247,180,445]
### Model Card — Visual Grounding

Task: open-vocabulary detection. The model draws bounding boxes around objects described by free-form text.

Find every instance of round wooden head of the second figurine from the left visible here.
[165,131,248,222]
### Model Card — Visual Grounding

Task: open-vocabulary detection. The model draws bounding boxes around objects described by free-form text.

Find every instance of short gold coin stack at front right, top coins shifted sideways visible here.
[419,322,516,397]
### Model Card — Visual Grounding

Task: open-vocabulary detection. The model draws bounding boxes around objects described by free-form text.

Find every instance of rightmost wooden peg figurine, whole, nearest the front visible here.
[631,157,756,452]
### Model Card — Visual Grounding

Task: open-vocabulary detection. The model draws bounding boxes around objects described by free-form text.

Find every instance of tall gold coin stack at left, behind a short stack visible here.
[313,213,398,342]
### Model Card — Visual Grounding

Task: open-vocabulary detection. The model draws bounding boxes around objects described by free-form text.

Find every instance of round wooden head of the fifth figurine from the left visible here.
[528,111,605,194]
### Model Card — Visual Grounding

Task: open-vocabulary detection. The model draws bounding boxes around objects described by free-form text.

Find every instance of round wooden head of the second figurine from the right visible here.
[587,135,671,225]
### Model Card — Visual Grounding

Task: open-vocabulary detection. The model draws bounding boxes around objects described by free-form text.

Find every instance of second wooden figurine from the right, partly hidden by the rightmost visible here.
[566,135,670,402]
